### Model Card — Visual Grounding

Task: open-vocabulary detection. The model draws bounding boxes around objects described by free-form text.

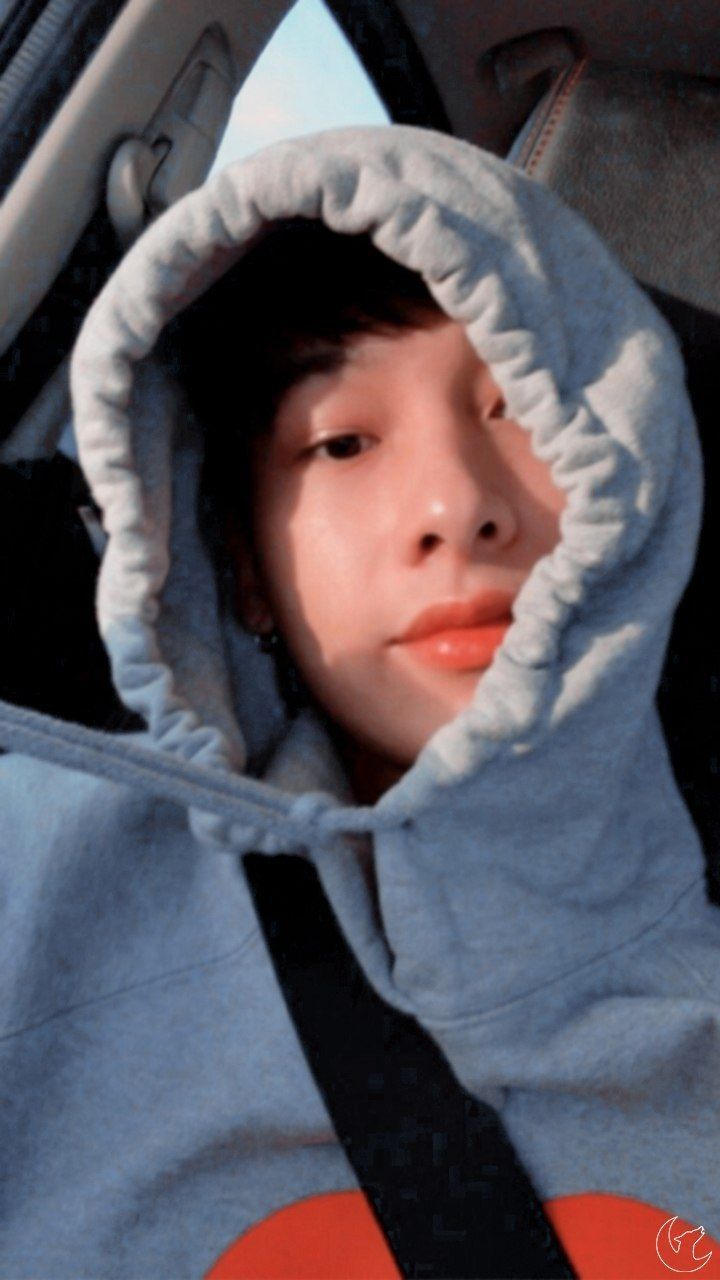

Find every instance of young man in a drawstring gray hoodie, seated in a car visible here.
[3,127,720,1280]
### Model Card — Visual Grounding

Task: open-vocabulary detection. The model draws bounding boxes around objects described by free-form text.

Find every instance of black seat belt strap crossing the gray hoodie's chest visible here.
[243,854,575,1280]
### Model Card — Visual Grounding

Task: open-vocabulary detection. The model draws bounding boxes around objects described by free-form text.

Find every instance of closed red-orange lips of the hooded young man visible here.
[392,591,514,671]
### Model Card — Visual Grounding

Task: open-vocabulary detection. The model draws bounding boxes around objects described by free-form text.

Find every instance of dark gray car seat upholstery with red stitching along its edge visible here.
[509,59,720,312]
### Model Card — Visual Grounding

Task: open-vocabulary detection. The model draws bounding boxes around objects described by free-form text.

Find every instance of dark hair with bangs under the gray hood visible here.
[163,218,443,515]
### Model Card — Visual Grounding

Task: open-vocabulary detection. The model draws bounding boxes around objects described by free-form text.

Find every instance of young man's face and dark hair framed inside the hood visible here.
[174,219,565,803]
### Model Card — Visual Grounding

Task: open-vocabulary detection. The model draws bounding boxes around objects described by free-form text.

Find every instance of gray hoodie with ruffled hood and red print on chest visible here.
[0,125,720,1280]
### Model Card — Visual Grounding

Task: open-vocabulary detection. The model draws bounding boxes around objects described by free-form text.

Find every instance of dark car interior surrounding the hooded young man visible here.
[0,0,720,904]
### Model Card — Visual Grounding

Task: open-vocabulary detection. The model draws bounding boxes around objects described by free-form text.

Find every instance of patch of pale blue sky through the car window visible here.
[207,0,388,172]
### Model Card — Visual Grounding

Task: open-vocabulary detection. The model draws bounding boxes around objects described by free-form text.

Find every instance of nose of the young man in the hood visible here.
[401,424,519,563]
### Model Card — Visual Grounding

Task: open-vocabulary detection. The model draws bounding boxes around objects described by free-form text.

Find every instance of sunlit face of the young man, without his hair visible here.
[240,317,565,790]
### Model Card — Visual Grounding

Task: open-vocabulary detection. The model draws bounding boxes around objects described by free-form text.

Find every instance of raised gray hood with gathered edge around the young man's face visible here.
[72,125,702,1007]
